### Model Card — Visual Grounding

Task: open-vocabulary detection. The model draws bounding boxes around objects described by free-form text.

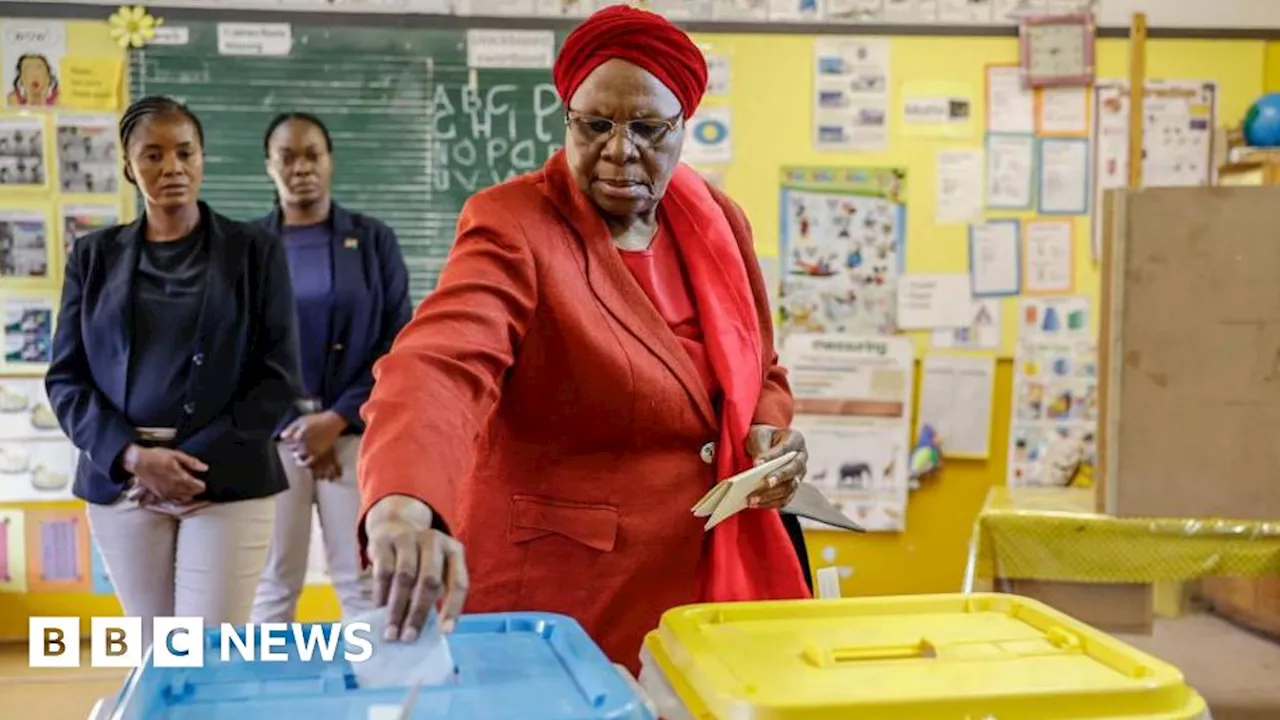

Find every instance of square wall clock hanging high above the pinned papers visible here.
[1018,13,1097,87]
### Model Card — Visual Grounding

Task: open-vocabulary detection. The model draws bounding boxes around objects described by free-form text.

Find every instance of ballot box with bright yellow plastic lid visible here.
[641,594,1208,720]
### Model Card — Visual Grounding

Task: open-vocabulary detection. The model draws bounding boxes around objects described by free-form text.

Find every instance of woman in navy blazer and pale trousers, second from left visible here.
[253,113,412,623]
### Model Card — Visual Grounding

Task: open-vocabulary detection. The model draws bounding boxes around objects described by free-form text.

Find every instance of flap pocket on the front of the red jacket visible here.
[507,495,618,552]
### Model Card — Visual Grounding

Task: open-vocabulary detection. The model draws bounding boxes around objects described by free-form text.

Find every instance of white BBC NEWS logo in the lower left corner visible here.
[27,618,374,667]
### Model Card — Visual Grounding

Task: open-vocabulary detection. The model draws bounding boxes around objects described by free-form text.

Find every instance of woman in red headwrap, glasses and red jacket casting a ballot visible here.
[358,6,810,670]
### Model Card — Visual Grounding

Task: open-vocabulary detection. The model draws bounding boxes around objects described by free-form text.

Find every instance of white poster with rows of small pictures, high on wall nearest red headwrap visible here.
[813,37,890,151]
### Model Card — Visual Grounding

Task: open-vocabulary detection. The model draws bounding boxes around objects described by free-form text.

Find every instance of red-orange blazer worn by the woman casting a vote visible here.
[358,154,792,670]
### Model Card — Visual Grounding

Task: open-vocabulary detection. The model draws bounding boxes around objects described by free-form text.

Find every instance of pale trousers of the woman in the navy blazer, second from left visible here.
[253,436,374,623]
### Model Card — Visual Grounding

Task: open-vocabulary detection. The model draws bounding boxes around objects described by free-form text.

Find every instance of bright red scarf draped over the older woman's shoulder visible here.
[662,164,809,602]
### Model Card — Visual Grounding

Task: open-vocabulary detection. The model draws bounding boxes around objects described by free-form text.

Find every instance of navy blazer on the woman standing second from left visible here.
[257,202,413,434]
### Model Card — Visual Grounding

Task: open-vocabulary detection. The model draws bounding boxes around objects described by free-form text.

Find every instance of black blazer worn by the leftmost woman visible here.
[45,202,301,505]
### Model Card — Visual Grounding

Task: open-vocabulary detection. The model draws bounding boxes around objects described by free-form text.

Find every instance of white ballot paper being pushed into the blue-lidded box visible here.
[349,607,454,688]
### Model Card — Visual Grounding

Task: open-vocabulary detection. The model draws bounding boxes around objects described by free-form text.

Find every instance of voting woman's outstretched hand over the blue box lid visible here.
[365,495,470,642]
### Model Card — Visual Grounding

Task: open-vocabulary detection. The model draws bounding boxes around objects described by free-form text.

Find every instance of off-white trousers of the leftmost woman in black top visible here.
[88,489,275,647]
